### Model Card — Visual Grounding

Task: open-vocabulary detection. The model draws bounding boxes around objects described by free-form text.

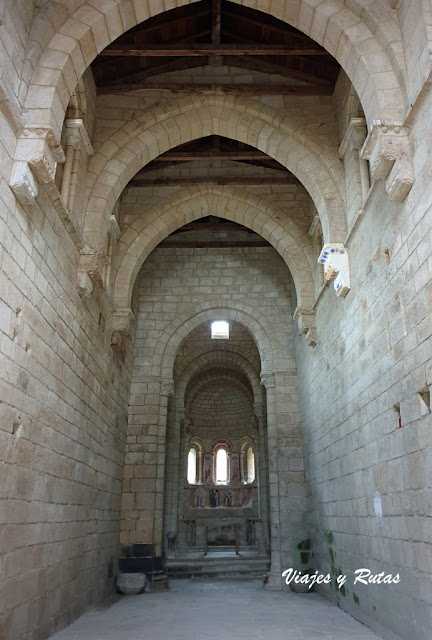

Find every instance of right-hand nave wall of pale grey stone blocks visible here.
[297,92,432,639]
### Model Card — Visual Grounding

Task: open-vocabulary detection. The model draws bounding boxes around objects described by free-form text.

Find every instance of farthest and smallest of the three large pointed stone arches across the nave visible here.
[114,187,314,308]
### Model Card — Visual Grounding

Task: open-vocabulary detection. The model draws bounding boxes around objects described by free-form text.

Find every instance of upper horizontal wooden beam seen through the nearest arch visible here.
[99,43,330,58]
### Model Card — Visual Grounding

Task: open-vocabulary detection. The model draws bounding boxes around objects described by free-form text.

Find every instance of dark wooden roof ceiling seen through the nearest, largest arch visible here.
[92,0,340,95]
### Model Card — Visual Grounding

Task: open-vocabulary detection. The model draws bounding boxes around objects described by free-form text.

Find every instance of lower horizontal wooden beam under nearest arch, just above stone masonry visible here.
[98,82,333,96]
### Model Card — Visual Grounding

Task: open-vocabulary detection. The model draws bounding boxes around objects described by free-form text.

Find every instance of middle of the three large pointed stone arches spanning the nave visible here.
[84,96,346,248]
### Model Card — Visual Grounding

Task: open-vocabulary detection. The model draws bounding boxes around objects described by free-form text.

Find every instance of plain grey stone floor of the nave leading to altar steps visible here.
[51,579,381,640]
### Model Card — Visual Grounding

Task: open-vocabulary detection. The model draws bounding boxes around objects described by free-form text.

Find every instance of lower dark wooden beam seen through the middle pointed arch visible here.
[128,175,299,187]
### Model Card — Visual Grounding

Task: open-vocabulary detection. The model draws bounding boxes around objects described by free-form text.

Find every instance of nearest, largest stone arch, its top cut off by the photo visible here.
[24,0,406,136]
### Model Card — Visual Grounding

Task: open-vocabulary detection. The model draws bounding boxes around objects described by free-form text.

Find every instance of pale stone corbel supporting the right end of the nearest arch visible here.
[360,123,414,202]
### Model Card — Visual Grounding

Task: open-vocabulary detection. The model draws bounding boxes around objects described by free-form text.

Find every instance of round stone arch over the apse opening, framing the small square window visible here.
[152,302,280,380]
